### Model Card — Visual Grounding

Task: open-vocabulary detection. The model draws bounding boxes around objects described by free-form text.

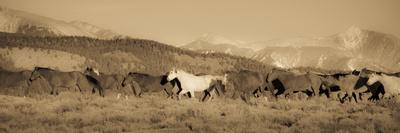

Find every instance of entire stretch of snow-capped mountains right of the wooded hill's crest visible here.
[181,26,400,71]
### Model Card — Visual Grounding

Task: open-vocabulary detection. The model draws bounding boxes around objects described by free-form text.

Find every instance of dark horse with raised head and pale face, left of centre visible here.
[84,67,124,97]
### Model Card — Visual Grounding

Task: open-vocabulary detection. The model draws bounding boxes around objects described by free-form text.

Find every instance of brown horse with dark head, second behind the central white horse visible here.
[266,69,321,98]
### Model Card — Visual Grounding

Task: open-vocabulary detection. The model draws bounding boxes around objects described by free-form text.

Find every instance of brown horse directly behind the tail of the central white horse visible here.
[224,70,266,103]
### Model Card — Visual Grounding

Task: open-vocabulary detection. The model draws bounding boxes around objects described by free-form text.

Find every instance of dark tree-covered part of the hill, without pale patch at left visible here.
[0,33,271,74]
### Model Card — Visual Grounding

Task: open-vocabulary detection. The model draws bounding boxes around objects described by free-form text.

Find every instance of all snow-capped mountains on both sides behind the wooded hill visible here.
[0,7,400,72]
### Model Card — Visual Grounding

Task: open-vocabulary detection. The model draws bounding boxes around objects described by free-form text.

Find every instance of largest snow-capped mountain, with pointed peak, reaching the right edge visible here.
[252,27,400,71]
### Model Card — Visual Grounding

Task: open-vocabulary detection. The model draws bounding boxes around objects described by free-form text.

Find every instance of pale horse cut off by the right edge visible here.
[367,73,400,98]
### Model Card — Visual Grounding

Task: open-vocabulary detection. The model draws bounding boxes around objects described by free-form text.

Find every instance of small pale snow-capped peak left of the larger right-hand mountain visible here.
[181,34,254,57]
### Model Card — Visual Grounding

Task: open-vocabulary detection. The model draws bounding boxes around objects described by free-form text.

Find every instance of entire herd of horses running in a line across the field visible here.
[0,67,400,103]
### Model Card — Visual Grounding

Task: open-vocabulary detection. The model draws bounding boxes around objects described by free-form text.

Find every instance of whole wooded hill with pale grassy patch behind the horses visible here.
[0,33,269,74]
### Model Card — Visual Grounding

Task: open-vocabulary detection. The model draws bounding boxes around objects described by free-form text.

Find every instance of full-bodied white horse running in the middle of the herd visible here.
[167,70,226,99]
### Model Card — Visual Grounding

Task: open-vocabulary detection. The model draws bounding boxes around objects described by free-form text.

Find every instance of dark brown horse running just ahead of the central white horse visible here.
[121,72,180,98]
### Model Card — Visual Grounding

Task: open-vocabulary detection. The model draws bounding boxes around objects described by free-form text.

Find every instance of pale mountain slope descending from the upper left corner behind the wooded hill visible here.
[0,7,124,39]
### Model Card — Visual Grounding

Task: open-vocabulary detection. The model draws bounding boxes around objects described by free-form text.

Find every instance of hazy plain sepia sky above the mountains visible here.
[0,0,400,45]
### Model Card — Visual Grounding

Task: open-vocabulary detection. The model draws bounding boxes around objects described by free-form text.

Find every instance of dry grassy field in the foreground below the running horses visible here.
[0,93,400,133]
